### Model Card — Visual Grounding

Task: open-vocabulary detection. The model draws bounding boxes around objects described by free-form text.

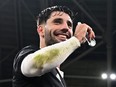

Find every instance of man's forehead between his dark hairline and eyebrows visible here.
[49,11,72,22]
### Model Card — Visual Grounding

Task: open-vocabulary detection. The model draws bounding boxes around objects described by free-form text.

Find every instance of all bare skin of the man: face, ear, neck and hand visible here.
[37,11,95,48]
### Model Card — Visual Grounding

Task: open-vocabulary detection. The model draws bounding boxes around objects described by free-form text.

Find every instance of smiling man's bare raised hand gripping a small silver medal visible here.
[74,22,95,43]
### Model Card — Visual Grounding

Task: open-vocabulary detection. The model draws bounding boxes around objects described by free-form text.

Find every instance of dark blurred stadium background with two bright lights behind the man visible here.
[0,0,116,87]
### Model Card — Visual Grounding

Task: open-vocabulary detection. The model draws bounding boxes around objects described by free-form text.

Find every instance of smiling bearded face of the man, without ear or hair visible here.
[45,11,73,46]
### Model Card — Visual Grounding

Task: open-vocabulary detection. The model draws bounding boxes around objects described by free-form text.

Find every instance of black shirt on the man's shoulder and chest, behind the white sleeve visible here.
[12,46,66,87]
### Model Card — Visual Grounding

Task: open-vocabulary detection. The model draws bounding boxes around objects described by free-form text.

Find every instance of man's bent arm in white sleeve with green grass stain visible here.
[21,37,80,77]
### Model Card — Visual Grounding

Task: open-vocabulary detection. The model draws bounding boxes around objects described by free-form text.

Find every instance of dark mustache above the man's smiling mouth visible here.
[53,29,71,38]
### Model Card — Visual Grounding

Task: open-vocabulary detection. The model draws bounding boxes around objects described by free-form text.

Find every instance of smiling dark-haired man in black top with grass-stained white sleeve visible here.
[13,6,95,87]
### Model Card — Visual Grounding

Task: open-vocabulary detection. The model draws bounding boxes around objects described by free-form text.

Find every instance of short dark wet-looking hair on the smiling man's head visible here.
[37,6,74,24]
